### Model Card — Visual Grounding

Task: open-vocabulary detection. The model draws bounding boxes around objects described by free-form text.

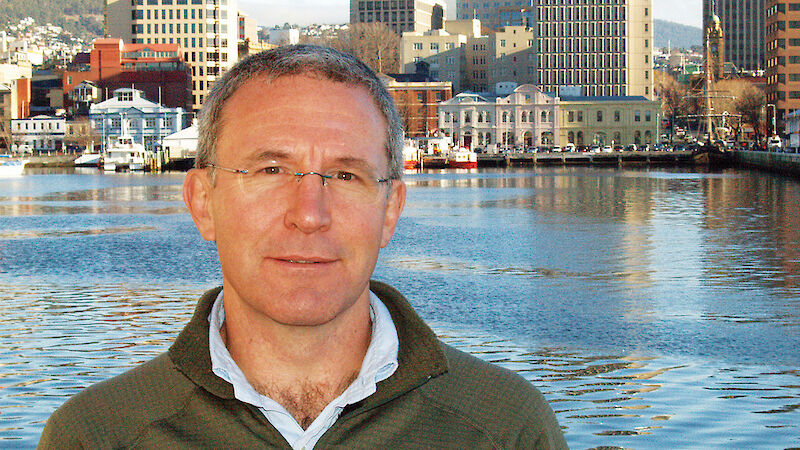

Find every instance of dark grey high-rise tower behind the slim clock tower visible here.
[703,0,764,71]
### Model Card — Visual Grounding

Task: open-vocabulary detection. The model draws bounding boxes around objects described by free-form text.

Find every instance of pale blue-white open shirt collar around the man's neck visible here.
[208,291,400,449]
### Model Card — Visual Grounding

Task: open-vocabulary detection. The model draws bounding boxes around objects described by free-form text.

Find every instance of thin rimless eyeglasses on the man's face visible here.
[208,164,392,203]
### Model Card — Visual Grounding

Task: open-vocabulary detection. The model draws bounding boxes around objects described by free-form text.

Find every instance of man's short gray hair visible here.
[195,45,403,179]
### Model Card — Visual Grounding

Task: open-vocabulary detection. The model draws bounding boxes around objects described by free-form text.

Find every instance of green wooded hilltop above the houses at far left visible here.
[0,0,103,37]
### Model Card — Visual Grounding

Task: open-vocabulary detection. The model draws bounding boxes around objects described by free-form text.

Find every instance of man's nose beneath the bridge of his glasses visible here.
[284,172,332,233]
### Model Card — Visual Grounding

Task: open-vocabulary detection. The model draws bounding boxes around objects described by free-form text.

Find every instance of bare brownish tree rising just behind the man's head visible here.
[329,22,400,73]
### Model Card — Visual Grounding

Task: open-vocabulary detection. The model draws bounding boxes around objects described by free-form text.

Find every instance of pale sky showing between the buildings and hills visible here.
[239,0,703,27]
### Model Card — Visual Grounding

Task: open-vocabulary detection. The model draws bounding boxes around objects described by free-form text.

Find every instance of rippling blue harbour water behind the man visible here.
[0,167,800,449]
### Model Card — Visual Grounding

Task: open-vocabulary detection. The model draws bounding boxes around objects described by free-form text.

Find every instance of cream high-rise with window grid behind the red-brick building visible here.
[105,0,239,111]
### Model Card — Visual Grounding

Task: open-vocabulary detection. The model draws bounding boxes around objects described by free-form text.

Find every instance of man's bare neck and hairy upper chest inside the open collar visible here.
[220,291,371,429]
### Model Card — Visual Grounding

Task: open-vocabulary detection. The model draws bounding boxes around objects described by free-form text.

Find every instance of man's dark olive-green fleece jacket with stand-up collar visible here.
[39,282,566,449]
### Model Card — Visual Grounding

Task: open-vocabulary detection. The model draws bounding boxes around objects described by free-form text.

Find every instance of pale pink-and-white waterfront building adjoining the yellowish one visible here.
[439,84,560,152]
